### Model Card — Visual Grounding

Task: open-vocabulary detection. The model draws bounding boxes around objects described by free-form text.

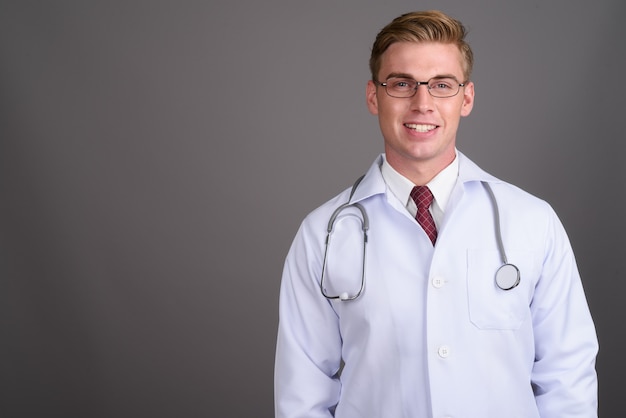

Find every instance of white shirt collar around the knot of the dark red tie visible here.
[380,152,459,213]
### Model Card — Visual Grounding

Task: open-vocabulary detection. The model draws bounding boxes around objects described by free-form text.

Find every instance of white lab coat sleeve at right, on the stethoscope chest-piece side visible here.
[531,208,598,418]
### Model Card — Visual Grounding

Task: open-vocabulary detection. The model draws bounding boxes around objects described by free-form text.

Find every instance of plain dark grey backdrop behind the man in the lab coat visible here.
[0,0,626,418]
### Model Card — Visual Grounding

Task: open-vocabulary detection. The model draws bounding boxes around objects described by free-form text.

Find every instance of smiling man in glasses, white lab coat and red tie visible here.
[275,11,598,418]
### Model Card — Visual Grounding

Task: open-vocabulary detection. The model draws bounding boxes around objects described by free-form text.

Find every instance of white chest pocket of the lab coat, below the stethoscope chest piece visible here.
[467,250,535,330]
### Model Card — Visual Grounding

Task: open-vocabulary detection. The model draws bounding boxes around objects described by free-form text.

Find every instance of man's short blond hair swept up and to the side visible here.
[370,10,474,82]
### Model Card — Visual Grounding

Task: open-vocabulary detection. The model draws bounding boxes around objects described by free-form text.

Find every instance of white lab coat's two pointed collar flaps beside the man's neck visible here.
[351,150,501,203]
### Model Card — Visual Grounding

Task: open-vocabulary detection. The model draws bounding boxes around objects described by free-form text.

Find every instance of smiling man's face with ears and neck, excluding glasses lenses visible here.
[367,42,474,180]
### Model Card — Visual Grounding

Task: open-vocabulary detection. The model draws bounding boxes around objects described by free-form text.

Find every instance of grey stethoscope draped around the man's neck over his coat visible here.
[320,176,520,301]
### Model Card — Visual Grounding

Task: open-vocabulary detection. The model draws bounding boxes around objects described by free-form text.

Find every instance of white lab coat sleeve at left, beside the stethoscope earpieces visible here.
[274,220,341,418]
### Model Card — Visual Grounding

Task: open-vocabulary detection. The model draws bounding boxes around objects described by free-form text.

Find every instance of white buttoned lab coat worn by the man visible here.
[275,153,598,418]
